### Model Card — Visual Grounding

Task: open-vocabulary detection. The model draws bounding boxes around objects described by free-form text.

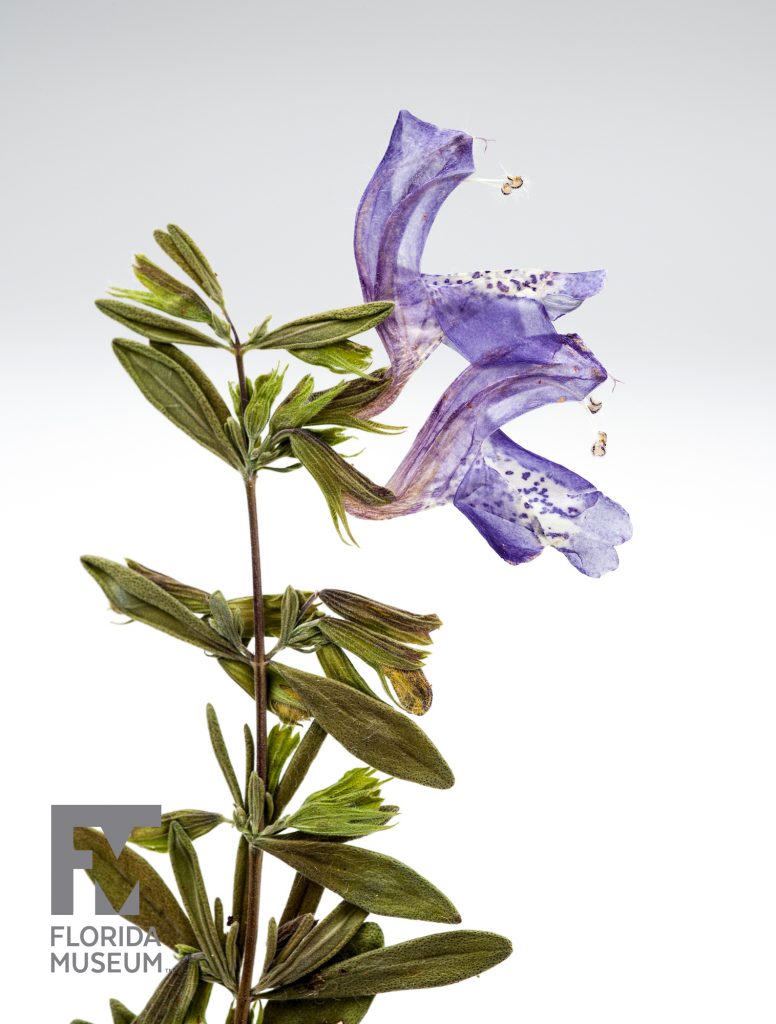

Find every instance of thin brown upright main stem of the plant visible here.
[229,335,267,1024]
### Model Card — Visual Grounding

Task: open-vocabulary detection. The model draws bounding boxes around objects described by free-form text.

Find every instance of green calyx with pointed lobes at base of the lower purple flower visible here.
[290,430,394,543]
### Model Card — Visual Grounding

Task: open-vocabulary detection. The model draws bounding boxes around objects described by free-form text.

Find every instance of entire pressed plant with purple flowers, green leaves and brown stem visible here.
[76,112,630,1024]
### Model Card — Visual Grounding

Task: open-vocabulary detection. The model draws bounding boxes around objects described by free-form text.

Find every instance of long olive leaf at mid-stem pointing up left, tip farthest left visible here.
[81,555,235,657]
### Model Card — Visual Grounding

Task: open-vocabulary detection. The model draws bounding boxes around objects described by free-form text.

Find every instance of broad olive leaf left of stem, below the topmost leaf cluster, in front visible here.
[114,338,243,470]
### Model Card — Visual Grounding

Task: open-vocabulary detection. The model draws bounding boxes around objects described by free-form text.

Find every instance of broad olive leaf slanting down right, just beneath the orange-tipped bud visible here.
[272,662,455,790]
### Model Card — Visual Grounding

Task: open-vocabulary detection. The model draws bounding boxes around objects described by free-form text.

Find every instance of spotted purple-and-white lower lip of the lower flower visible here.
[455,431,632,577]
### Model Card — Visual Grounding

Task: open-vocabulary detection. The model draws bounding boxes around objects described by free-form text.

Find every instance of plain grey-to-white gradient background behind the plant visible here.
[0,0,776,1024]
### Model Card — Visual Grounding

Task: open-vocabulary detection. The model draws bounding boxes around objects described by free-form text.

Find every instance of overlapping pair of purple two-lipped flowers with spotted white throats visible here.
[351,111,631,577]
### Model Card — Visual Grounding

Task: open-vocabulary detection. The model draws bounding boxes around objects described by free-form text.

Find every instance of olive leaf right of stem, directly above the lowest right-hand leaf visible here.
[255,837,461,924]
